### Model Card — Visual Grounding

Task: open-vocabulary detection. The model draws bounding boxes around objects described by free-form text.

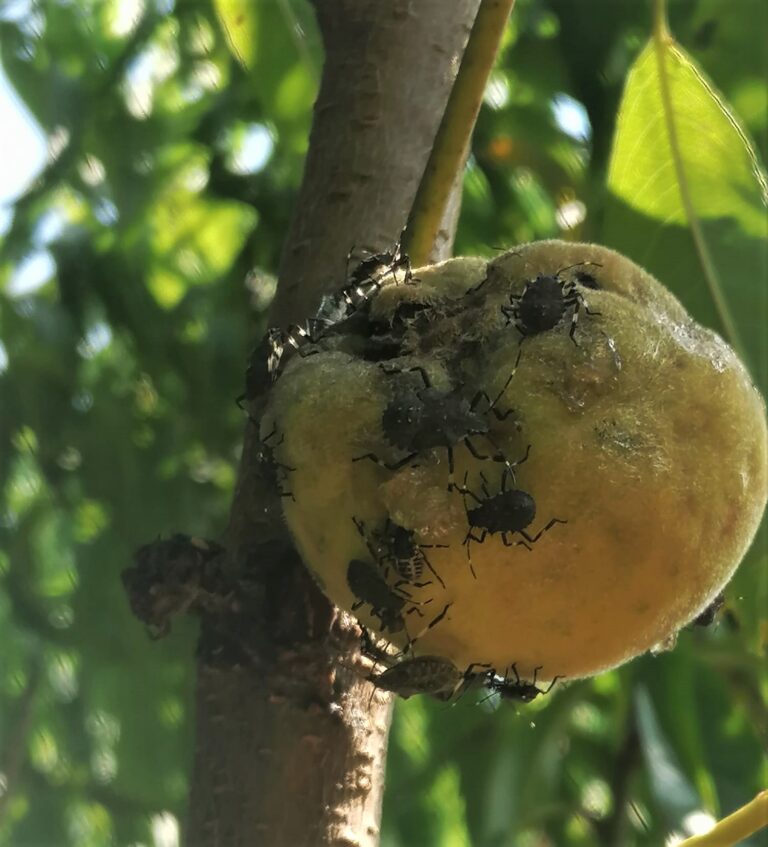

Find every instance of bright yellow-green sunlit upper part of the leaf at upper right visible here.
[608,43,768,236]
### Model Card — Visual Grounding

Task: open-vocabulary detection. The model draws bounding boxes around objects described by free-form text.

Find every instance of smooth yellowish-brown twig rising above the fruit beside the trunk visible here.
[403,0,515,267]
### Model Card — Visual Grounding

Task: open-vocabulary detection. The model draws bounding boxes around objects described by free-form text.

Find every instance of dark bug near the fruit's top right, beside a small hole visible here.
[501,262,602,344]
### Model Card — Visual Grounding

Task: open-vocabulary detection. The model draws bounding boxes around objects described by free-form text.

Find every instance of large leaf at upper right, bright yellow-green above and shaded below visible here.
[604,32,768,382]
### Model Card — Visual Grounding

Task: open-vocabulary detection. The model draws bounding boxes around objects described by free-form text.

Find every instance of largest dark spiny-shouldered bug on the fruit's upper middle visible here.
[353,366,514,490]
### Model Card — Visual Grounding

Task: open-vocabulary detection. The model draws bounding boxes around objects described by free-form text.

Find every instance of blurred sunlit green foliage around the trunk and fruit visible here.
[0,0,768,847]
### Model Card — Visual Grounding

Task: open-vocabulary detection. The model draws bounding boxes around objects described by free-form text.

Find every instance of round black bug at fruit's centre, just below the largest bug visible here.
[457,460,567,577]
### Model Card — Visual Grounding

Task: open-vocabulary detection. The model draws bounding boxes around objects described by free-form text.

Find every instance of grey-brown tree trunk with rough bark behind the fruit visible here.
[187,0,479,847]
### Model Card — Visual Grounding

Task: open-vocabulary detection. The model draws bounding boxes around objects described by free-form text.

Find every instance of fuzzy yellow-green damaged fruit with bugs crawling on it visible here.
[262,241,767,679]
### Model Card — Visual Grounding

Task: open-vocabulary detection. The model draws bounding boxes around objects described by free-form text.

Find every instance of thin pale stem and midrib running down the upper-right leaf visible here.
[653,0,747,362]
